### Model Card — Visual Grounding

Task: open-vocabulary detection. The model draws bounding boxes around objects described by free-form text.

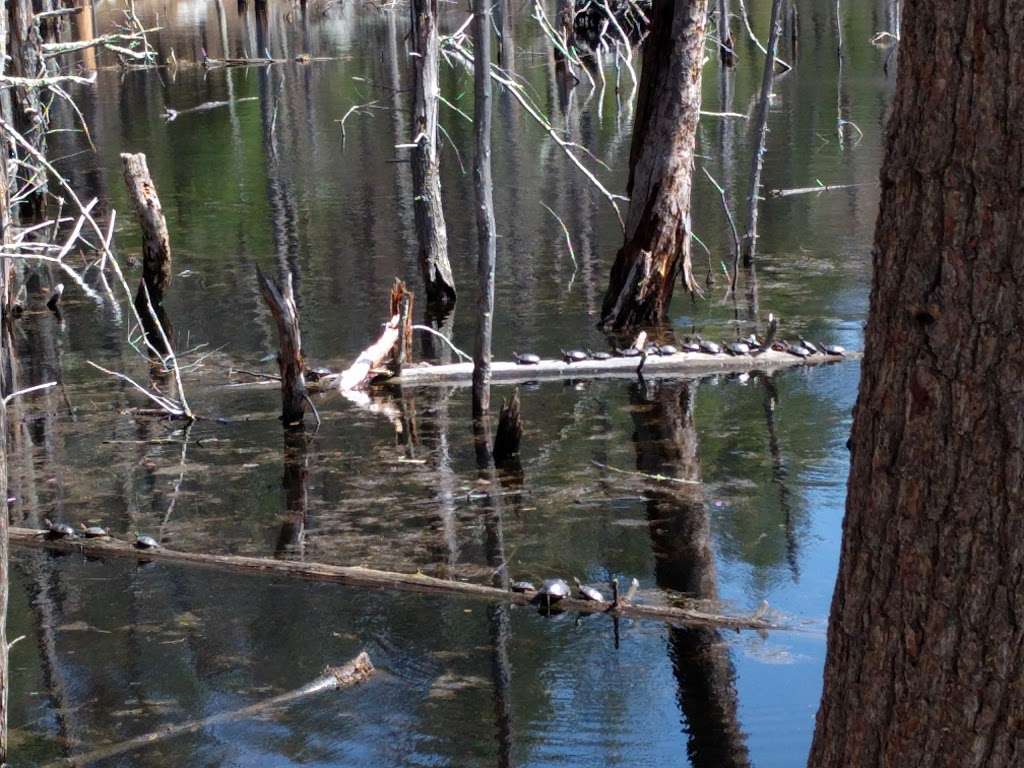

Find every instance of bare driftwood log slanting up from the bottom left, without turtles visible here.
[46,651,374,768]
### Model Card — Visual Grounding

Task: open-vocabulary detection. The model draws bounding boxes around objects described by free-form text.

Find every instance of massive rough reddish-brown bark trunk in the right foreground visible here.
[809,0,1024,768]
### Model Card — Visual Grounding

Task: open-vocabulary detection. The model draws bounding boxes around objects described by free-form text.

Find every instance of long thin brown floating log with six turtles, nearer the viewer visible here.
[10,527,774,630]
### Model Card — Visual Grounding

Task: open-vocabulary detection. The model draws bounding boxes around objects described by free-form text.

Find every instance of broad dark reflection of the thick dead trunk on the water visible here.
[630,380,750,768]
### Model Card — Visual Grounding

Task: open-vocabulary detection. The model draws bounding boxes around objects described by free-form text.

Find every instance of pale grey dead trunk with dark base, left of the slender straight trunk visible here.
[410,0,456,313]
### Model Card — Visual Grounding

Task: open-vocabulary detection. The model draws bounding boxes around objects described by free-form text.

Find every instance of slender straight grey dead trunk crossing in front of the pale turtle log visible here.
[473,0,497,419]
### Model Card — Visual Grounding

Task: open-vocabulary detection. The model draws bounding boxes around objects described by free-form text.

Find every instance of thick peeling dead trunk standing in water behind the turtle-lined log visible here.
[601,0,708,328]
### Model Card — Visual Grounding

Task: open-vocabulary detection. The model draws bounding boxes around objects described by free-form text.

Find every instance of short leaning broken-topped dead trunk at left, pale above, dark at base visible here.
[121,153,171,354]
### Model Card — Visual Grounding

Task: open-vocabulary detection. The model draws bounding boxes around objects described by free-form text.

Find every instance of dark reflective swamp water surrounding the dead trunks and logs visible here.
[8,0,890,766]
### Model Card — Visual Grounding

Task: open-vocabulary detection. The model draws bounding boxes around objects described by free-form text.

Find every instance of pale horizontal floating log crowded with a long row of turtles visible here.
[388,349,859,386]
